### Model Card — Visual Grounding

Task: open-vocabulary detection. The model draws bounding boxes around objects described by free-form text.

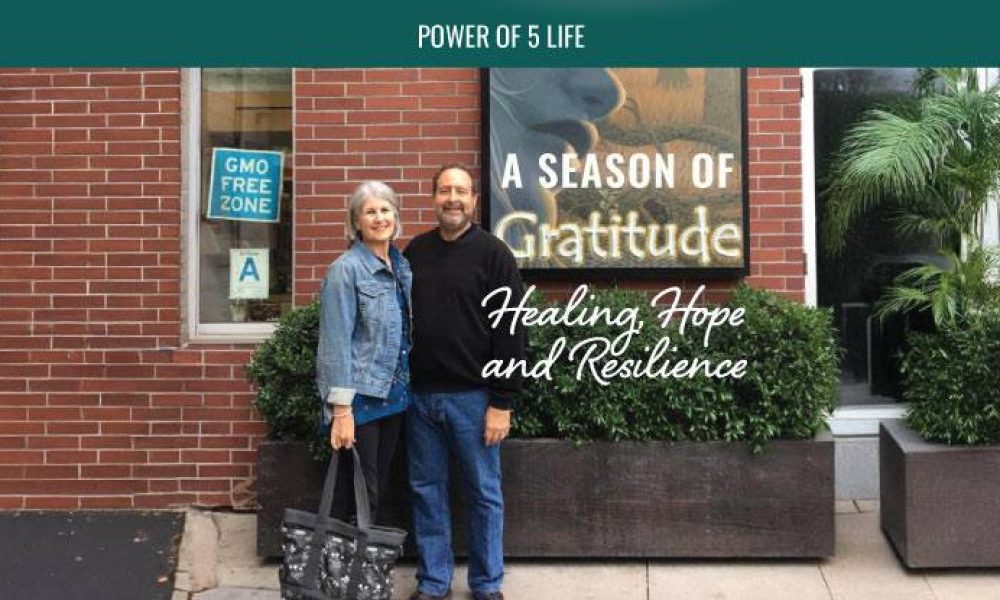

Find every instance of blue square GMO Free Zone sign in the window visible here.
[208,148,285,223]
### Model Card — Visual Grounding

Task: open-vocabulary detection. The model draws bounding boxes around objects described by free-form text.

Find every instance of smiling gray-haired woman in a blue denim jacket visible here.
[316,181,413,521]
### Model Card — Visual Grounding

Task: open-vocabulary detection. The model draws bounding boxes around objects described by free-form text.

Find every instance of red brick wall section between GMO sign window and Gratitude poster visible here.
[295,69,480,304]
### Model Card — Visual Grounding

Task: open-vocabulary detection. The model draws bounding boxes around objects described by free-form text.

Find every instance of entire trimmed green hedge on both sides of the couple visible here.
[247,287,839,448]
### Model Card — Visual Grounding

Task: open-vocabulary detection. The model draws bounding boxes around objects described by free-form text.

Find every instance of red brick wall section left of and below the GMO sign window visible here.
[0,69,263,508]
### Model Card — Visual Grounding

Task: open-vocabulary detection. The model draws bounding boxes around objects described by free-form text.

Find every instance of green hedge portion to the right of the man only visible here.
[514,286,839,448]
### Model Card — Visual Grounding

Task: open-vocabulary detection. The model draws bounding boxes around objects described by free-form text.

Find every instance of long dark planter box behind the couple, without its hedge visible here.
[258,435,834,558]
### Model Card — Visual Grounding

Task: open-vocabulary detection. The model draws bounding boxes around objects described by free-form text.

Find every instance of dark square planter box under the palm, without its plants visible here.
[879,420,1000,568]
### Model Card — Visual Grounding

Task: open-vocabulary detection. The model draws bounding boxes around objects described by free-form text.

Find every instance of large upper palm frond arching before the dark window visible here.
[822,68,1000,255]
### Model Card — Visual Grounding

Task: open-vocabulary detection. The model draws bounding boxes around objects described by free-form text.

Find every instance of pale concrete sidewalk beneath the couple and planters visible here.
[173,500,1000,600]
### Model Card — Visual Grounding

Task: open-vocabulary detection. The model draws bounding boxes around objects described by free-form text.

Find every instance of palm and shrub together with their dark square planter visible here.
[828,69,1000,567]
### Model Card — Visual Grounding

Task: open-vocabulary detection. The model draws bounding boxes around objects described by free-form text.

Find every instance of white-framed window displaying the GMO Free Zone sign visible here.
[185,69,293,339]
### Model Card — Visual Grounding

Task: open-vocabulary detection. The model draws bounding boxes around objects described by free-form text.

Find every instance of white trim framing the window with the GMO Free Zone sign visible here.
[181,68,286,343]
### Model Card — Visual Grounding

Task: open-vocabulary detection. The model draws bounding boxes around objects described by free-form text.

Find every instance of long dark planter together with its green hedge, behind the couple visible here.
[248,288,838,557]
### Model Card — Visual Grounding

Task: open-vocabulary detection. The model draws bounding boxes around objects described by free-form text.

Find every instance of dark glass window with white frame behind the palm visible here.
[802,69,1000,435]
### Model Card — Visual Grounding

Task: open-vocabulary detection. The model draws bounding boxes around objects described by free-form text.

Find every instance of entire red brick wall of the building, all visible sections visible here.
[0,69,804,509]
